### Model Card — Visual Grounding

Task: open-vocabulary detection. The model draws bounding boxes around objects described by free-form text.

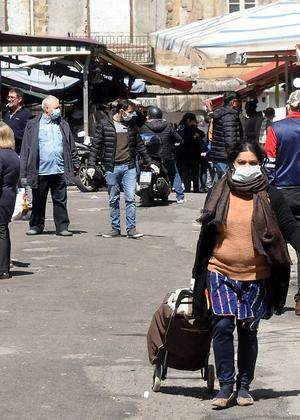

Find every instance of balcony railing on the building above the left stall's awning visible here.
[91,32,153,65]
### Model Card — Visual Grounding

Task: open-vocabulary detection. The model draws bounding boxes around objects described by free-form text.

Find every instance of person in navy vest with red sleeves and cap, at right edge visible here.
[265,90,300,315]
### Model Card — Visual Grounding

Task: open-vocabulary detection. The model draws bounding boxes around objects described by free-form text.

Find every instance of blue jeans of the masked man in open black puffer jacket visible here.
[105,164,136,232]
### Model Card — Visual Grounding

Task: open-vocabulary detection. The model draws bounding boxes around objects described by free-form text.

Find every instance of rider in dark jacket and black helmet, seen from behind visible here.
[140,106,184,204]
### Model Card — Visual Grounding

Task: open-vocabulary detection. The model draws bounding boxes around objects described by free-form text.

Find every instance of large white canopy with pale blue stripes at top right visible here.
[152,0,300,58]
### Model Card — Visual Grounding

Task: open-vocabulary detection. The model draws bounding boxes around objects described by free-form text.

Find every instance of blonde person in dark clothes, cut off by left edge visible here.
[0,122,20,279]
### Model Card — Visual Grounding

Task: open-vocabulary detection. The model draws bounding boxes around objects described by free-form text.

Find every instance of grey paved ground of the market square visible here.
[0,190,300,420]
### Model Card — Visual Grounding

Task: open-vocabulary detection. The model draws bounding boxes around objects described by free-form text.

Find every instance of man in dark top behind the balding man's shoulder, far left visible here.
[3,88,32,155]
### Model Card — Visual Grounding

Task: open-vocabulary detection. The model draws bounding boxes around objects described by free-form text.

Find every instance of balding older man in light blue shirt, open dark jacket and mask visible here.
[20,96,80,236]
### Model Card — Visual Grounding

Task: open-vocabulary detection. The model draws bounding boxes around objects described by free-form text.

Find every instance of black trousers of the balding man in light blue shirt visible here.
[29,174,70,232]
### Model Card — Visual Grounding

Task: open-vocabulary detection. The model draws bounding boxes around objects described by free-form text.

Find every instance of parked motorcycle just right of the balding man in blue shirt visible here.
[75,131,106,192]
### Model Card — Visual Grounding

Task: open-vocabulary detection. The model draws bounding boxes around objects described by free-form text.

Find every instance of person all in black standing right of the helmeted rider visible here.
[177,112,204,193]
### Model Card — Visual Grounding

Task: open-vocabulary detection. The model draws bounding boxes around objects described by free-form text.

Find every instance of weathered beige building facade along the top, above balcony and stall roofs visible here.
[0,0,276,36]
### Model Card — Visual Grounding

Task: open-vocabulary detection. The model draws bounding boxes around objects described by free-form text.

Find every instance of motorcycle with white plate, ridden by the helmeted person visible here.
[136,133,171,207]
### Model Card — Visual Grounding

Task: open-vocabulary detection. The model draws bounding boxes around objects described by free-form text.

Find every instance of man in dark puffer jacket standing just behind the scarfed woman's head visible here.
[210,92,243,180]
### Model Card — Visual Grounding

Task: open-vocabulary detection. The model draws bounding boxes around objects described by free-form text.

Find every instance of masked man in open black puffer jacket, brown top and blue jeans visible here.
[87,100,158,239]
